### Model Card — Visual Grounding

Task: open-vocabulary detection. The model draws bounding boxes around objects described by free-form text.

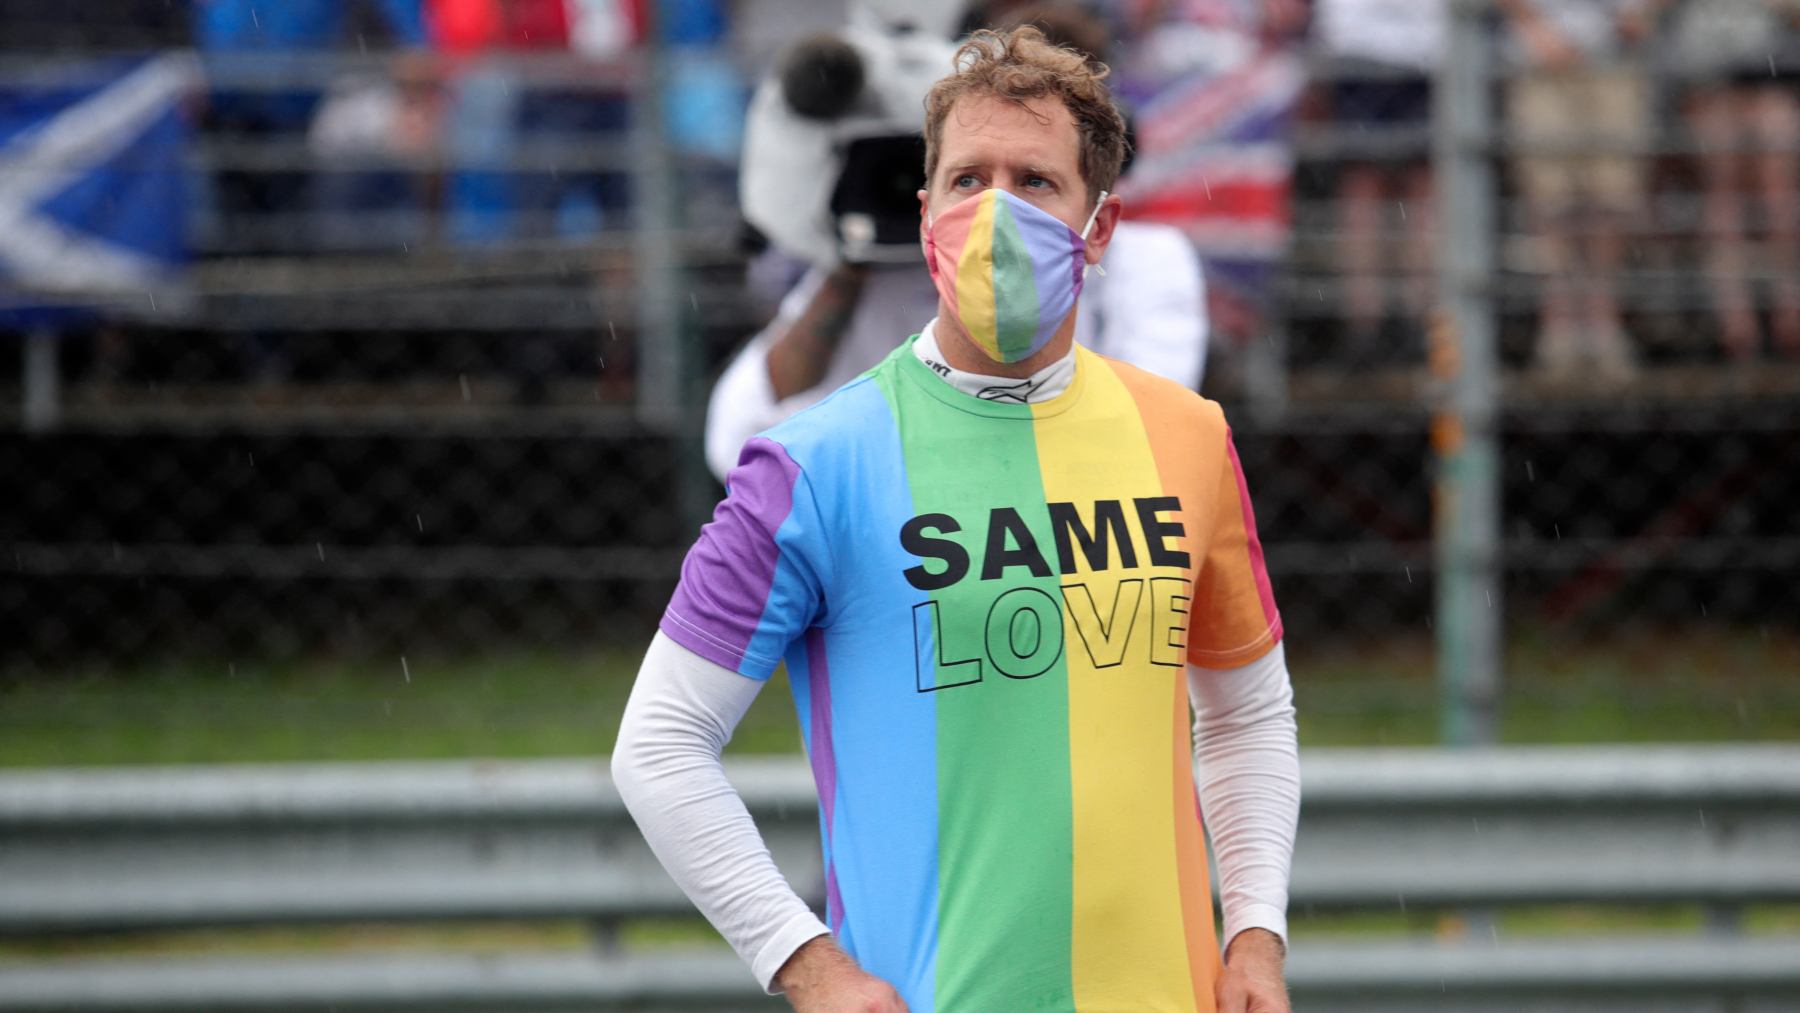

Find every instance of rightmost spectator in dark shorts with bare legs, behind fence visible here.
[1665,0,1800,362]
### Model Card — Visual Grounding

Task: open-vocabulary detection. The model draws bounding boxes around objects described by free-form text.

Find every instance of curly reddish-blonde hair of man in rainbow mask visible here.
[925,25,1125,202]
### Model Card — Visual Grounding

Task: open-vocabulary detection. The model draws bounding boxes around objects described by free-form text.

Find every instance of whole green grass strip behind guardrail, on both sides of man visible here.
[0,628,1800,768]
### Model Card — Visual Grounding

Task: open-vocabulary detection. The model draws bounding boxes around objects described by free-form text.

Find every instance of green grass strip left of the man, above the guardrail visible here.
[0,648,797,766]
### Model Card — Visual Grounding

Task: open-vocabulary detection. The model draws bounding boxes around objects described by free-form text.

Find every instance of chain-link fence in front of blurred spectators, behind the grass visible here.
[0,0,1800,730]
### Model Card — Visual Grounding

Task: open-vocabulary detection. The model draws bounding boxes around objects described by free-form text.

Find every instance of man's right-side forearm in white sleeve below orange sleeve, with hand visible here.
[1188,644,1300,1013]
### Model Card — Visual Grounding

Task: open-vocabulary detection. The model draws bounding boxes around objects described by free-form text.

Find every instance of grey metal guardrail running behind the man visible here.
[0,747,1800,1011]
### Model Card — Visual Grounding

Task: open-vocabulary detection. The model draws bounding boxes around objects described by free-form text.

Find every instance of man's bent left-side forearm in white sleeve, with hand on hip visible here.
[612,633,905,1013]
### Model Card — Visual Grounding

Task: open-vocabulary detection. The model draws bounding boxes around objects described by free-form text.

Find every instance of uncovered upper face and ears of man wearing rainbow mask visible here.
[918,95,1118,263]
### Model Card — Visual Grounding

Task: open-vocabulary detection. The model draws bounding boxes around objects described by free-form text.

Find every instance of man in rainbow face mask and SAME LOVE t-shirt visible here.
[612,27,1298,1013]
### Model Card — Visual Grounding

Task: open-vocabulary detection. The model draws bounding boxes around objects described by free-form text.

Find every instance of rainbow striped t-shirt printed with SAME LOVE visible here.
[662,345,1282,1013]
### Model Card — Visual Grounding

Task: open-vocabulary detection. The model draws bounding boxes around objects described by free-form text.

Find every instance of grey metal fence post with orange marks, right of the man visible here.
[1431,0,1501,745]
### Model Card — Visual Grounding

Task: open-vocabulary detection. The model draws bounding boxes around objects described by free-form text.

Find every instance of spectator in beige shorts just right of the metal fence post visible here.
[1501,0,1654,381]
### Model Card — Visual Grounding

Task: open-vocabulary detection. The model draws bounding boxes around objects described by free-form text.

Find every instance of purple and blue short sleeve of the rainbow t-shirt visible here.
[662,437,826,678]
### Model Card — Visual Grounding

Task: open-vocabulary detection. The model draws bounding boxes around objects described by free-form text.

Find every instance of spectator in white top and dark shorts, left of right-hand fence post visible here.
[1316,0,1444,365]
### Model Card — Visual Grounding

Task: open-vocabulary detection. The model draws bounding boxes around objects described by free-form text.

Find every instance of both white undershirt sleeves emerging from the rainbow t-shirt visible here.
[612,633,1300,991]
